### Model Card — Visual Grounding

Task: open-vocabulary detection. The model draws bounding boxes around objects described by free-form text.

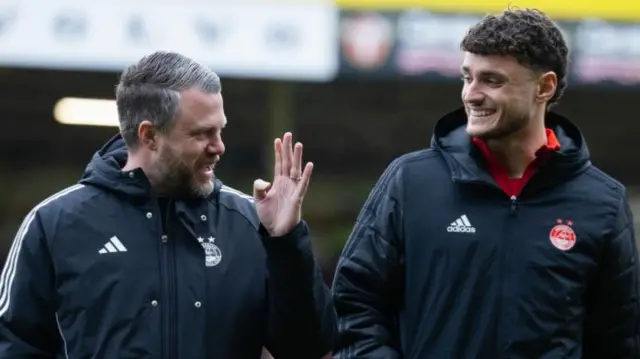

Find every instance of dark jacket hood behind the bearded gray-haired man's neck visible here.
[80,134,222,199]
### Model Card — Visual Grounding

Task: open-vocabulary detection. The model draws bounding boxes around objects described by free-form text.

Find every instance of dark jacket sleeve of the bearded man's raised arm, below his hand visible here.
[260,221,337,359]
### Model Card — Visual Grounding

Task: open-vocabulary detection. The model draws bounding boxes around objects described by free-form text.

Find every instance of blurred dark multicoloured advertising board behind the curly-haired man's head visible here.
[338,10,640,85]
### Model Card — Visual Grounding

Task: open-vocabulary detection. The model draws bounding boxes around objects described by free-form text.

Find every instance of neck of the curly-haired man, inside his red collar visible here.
[487,115,547,178]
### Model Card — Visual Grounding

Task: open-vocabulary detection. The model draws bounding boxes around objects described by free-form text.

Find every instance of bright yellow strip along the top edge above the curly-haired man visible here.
[336,0,640,21]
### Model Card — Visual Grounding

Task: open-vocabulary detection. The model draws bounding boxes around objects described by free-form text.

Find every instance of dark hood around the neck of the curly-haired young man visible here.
[431,107,591,190]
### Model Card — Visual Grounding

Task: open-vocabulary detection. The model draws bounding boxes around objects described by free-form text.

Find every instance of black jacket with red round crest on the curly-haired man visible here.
[333,109,640,359]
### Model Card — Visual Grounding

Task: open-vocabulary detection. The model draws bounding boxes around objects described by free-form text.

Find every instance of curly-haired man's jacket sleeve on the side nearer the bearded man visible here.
[333,160,404,359]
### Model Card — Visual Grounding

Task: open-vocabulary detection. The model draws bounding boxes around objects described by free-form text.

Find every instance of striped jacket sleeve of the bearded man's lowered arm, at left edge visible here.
[0,210,62,359]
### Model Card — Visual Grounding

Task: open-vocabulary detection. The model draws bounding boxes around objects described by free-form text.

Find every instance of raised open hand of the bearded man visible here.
[253,132,313,237]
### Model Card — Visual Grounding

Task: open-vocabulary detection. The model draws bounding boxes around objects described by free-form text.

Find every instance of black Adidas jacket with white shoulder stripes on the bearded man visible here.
[0,136,335,359]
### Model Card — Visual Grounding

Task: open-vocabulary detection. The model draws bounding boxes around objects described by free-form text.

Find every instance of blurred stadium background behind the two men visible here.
[0,0,640,300]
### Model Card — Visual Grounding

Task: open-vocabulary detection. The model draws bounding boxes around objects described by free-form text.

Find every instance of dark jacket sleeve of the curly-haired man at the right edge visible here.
[583,195,640,359]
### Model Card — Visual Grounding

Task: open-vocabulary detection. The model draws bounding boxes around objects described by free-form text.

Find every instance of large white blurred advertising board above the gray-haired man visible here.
[0,0,338,81]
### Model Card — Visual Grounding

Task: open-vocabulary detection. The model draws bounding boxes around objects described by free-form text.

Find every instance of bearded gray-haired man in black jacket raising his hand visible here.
[0,52,336,359]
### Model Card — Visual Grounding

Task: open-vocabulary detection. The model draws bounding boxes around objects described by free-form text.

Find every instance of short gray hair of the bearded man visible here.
[116,51,222,149]
